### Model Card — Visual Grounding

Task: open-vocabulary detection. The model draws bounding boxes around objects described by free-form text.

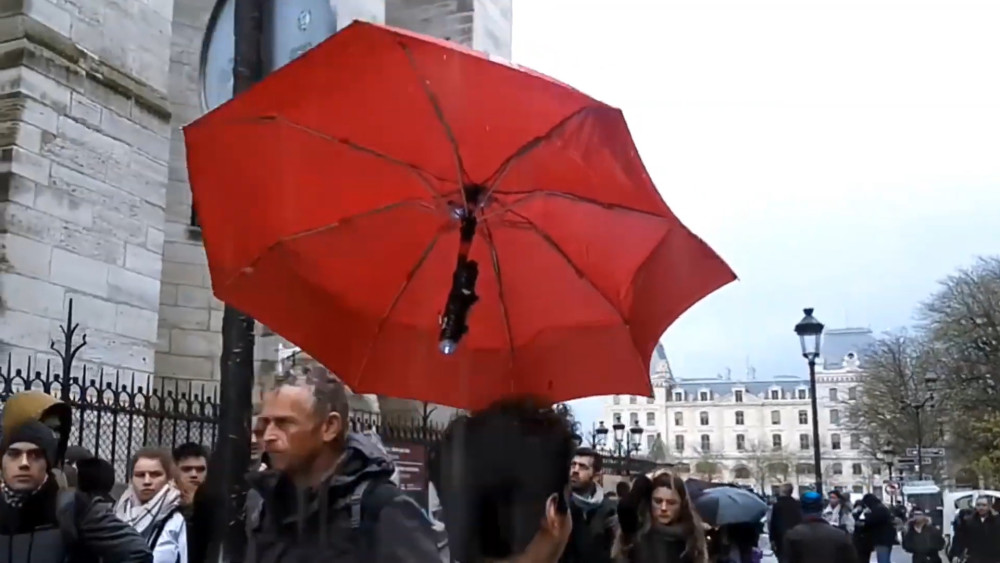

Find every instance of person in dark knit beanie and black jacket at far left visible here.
[0,420,152,563]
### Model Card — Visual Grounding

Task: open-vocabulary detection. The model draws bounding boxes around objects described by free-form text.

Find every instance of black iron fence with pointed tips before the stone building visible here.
[0,301,442,480]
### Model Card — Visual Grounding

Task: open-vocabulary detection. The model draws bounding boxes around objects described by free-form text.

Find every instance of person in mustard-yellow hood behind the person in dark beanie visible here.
[0,390,73,489]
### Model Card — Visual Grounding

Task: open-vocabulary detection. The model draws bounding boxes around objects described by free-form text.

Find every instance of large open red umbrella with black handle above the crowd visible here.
[185,23,735,408]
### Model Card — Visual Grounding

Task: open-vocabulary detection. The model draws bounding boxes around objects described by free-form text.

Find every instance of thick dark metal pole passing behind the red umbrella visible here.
[213,0,266,561]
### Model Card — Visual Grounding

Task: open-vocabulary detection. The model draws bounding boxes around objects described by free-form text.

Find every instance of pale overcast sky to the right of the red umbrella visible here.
[513,0,1000,428]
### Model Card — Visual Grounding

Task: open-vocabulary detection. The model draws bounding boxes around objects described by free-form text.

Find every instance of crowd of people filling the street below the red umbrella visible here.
[0,366,1000,563]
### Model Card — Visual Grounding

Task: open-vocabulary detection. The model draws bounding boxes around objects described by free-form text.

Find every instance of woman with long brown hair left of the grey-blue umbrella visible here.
[613,471,708,563]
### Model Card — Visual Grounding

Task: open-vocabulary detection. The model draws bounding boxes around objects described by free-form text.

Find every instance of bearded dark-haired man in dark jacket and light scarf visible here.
[561,448,618,563]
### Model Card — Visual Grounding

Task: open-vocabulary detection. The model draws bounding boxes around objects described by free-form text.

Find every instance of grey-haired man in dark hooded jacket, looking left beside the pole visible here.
[246,366,441,563]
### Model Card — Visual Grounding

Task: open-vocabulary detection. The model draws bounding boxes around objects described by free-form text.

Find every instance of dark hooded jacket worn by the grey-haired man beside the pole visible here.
[245,433,441,563]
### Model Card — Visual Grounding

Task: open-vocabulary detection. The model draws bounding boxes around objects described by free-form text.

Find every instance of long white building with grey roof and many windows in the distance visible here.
[604,329,884,494]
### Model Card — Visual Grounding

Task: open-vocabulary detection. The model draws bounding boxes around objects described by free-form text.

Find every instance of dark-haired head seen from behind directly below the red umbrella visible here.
[429,398,576,563]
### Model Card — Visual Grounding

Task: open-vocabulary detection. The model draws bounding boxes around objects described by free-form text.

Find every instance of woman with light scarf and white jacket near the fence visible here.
[115,448,188,563]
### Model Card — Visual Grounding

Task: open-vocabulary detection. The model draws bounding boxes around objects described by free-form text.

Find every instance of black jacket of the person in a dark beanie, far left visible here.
[0,478,153,563]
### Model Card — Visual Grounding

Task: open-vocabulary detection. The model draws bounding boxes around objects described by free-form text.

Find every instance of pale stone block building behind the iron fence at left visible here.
[0,0,511,418]
